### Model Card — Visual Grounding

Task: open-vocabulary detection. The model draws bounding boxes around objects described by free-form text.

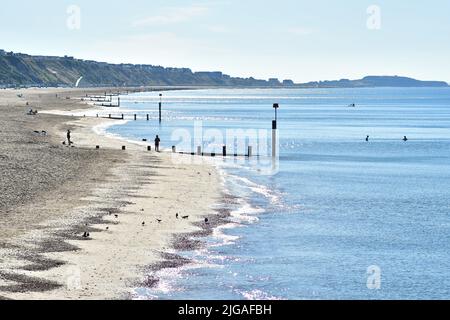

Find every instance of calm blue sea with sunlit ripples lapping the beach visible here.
[109,88,450,299]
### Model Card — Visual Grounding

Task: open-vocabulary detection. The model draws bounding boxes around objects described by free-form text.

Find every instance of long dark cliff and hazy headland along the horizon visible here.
[0,50,449,88]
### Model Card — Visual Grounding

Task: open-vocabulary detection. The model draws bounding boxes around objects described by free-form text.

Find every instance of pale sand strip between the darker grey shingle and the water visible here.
[0,90,227,300]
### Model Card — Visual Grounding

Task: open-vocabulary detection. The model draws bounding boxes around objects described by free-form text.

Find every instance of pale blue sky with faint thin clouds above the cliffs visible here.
[0,0,450,82]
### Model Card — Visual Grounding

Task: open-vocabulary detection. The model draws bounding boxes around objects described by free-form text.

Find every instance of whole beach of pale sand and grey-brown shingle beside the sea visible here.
[0,89,226,300]
